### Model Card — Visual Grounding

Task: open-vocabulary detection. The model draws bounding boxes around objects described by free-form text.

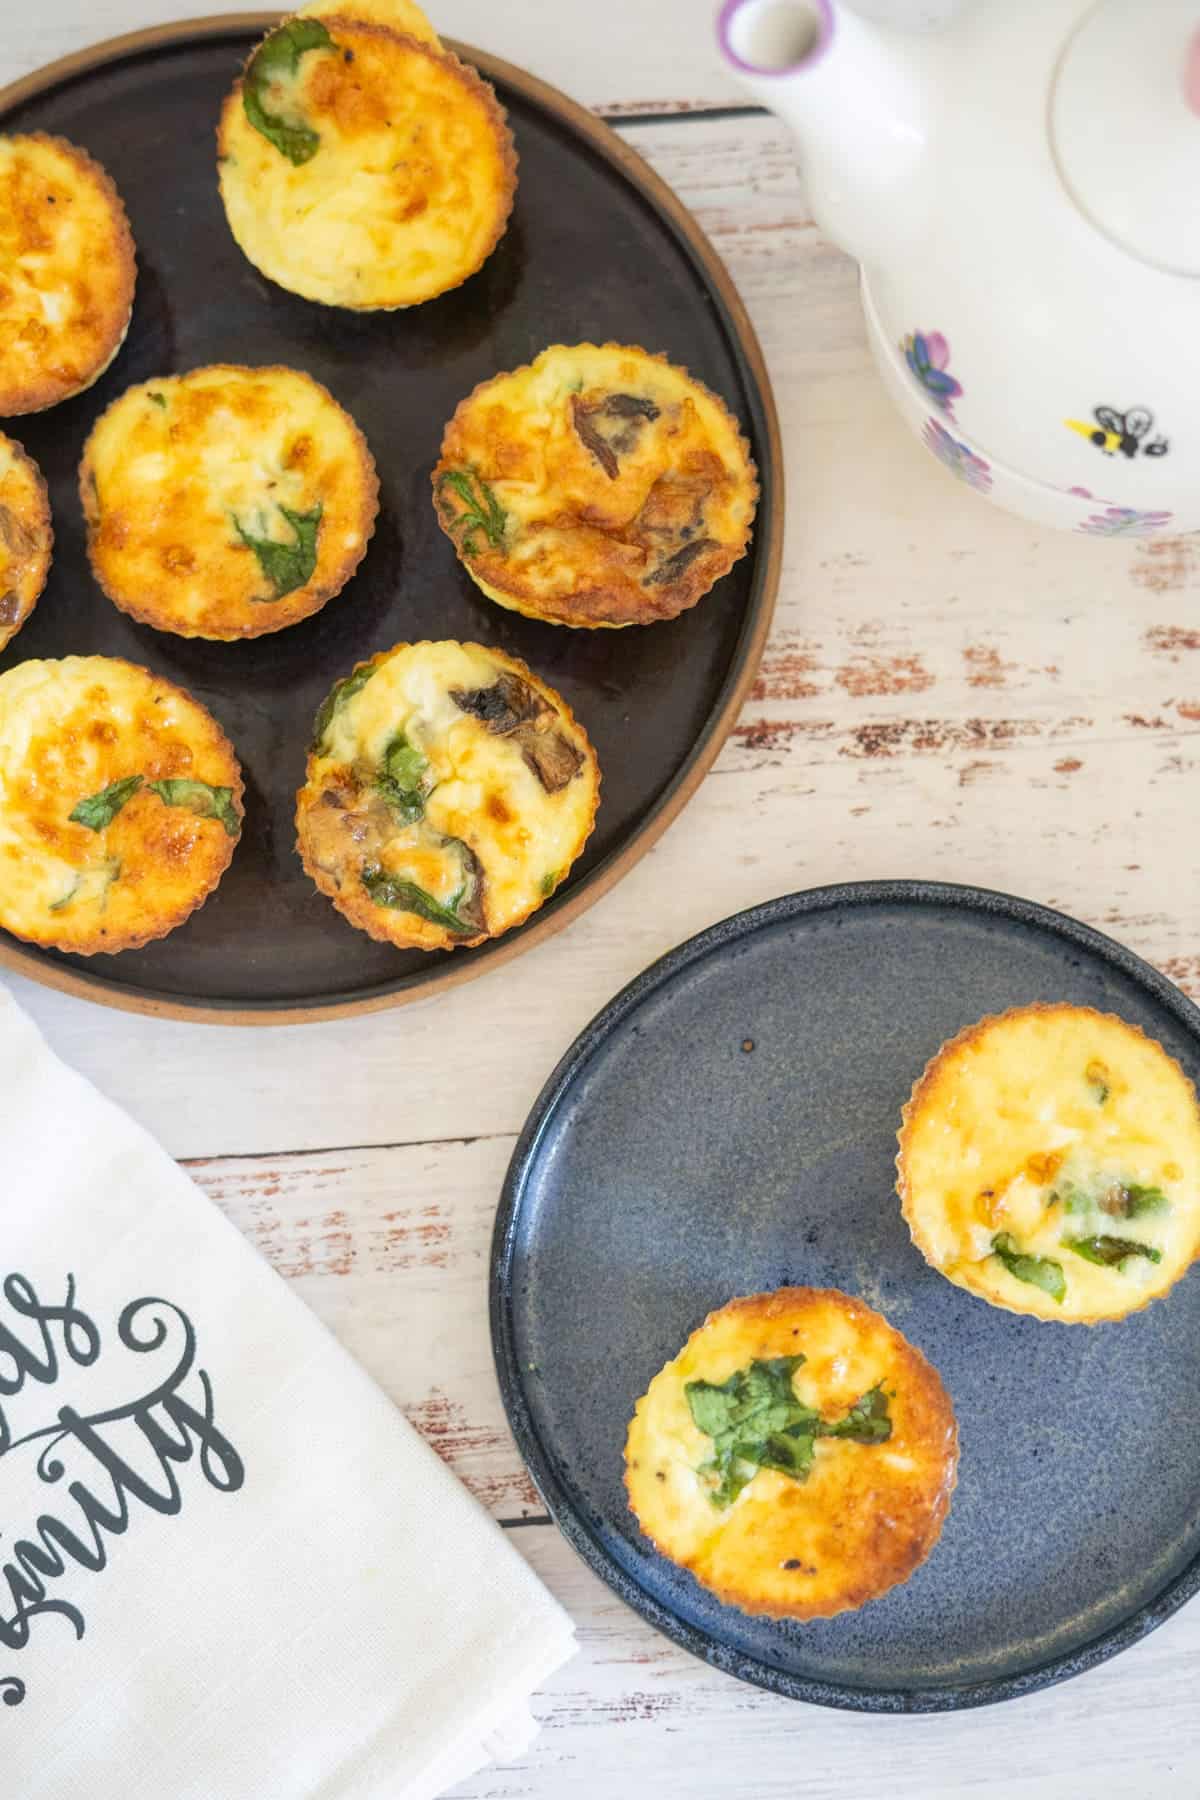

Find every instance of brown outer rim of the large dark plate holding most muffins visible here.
[0,9,786,1028]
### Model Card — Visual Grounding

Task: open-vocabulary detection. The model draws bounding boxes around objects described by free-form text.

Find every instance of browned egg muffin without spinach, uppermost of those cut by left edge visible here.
[0,131,135,418]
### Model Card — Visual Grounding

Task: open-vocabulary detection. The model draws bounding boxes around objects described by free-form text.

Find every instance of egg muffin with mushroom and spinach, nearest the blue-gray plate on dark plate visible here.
[297,643,599,950]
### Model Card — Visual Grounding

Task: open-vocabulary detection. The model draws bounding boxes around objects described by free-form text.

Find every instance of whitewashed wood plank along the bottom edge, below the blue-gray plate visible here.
[453,1526,1200,1800]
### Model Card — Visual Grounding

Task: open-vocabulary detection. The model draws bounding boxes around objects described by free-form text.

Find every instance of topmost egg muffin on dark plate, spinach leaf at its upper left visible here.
[218,13,516,311]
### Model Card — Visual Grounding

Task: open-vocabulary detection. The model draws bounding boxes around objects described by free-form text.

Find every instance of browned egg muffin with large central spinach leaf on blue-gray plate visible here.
[624,1287,959,1618]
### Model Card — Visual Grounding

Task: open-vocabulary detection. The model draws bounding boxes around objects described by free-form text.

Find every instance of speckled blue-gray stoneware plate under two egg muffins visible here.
[491,882,1200,1712]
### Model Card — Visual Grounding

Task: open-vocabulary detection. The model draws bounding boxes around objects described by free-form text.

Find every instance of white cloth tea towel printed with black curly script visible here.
[0,990,574,1800]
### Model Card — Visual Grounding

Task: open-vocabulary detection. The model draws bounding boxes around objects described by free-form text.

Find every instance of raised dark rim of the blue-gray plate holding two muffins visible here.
[488,880,1200,1714]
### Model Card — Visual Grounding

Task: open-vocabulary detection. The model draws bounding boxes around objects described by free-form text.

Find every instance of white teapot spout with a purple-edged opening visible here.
[716,0,930,263]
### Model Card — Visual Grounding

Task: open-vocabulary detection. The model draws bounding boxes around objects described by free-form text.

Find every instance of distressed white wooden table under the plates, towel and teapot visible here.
[0,0,1200,1800]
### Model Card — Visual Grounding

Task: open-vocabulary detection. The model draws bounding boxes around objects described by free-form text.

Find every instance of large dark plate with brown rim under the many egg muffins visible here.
[0,14,783,1024]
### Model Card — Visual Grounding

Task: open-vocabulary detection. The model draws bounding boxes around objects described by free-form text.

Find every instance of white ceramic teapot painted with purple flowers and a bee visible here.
[718,0,1200,536]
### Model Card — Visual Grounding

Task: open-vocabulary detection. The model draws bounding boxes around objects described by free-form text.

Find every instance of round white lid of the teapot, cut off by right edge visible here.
[1051,0,1200,275]
